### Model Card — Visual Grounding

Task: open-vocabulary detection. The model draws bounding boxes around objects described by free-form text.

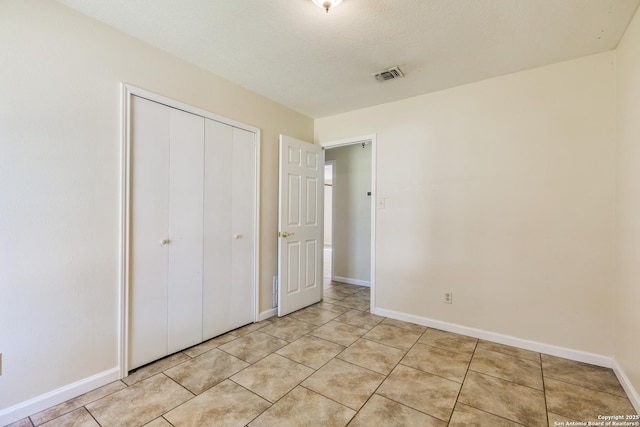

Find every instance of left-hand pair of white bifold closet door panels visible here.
[129,96,204,369]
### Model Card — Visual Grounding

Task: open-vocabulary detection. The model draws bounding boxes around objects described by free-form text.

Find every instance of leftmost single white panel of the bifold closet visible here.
[129,96,171,369]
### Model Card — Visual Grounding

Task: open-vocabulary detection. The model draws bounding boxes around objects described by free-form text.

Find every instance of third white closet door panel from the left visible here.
[202,119,232,340]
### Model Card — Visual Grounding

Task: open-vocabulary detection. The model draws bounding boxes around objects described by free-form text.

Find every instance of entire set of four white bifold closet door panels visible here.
[128,96,257,369]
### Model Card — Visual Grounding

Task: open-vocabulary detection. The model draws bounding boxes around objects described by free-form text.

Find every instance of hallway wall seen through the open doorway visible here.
[324,144,372,285]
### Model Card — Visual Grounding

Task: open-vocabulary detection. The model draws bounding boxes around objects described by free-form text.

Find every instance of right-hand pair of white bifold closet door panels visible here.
[203,120,257,339]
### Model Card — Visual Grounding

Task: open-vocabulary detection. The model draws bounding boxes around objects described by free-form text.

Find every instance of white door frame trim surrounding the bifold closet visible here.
[117,82,261,379]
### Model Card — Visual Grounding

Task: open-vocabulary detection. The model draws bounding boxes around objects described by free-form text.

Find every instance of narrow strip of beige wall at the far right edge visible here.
[615,5,640,401]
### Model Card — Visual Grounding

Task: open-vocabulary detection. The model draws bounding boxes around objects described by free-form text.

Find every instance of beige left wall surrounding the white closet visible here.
[0,0,313,414]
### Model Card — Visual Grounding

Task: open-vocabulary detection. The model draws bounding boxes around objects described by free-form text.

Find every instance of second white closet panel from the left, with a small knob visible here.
[167,109,204,354]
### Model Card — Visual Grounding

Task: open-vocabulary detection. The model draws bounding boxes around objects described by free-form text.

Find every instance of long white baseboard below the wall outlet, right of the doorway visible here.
[371,308,613,368]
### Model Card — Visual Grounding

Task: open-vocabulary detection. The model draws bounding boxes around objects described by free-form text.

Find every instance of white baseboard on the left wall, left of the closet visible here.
[0,367,120,426]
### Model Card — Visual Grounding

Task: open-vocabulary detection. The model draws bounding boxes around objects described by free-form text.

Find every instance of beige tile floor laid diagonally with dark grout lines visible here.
[7,283,635,427]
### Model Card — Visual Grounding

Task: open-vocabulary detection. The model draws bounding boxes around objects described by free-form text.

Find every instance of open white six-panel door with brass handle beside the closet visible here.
[278,135,324,316]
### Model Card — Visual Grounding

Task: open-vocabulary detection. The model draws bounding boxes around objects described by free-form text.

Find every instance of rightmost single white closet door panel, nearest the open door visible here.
[229,128,257,328]
